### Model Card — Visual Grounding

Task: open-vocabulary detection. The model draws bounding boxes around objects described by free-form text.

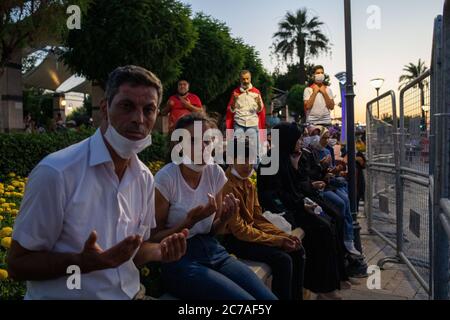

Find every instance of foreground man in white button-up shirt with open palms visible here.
[8,66,188,300]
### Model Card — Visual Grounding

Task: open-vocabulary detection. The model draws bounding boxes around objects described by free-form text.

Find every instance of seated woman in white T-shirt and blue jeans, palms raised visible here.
[152,113,276,300]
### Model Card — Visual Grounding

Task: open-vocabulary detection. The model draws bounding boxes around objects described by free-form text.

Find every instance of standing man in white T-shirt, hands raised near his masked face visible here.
[303,66,335,127]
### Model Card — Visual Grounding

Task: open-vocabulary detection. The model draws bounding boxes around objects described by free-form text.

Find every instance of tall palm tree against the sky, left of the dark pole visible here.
[273,8,330,84]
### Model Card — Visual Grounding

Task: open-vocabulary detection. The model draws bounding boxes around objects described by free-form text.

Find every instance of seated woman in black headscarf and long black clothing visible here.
[257,123,348,299]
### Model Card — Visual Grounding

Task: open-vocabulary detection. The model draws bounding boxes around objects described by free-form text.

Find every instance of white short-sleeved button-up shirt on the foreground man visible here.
[13,130,156,299]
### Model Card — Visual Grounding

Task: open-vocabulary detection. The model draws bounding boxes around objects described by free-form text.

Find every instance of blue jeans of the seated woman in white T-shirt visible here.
[162,235,277,300]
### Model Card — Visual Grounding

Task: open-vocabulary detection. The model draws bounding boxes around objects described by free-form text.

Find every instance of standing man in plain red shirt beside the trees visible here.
[161,79,203,131]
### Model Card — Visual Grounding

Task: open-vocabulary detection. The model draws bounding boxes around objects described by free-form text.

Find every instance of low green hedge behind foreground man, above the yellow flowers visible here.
[0,129,168,177]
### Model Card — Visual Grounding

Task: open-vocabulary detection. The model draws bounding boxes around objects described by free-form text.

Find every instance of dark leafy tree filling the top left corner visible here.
[0,0,90,76]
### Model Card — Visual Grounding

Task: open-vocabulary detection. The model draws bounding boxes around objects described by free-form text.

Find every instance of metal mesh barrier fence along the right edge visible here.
[365,0,450,299]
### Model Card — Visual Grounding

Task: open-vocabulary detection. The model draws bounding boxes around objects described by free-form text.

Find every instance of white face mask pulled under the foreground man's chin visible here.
[104,124,152,159]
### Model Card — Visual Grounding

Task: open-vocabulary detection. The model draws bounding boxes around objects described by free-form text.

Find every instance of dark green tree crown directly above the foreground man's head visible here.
[63,0,197,87]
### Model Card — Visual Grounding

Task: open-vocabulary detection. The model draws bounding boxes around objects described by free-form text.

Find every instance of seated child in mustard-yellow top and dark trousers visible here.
[223,139,305,300]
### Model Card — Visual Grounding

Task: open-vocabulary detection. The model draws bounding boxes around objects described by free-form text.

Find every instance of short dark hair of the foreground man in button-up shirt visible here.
[105,65,163,107]
